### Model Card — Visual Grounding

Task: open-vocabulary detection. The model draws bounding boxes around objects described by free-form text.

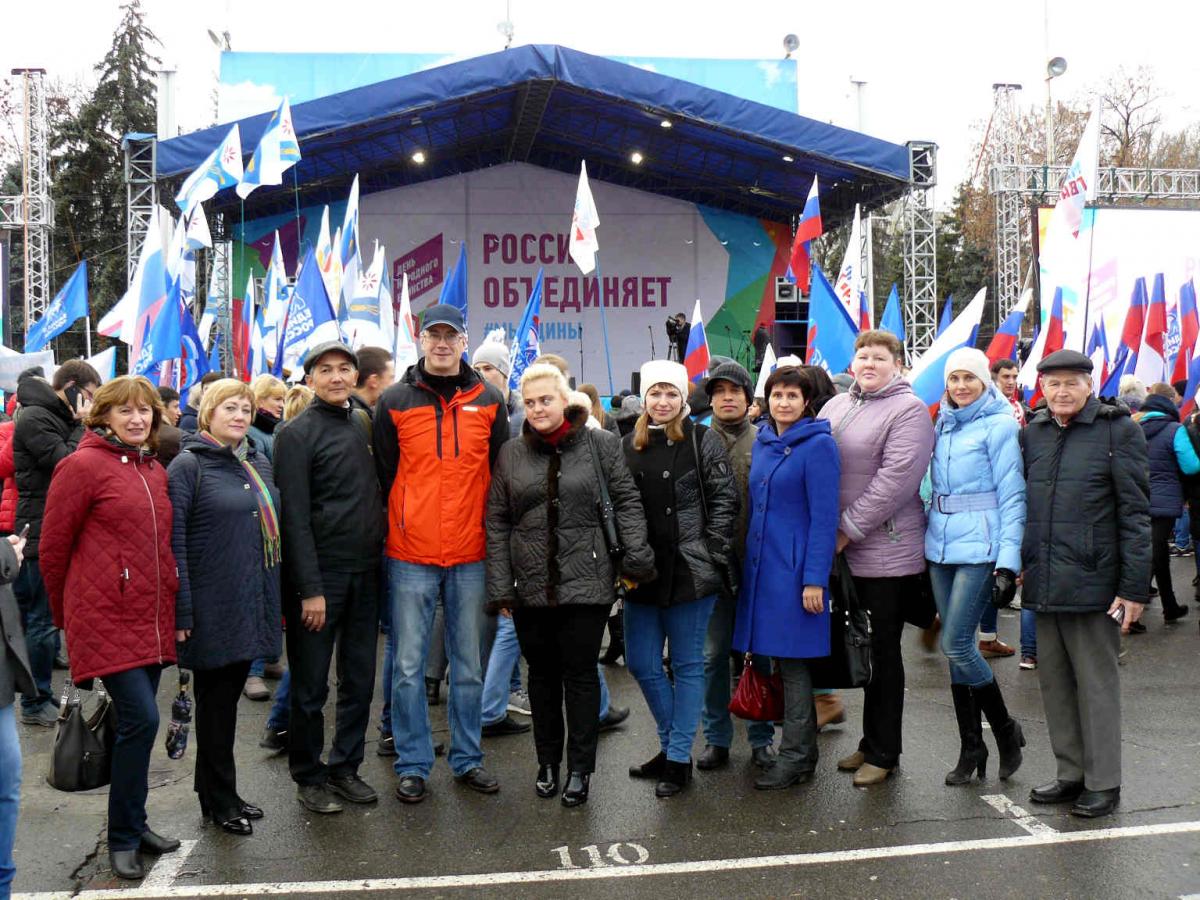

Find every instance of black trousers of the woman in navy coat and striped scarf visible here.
[193,660,251,822]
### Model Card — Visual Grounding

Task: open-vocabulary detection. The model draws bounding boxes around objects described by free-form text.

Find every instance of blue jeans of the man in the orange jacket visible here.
[388,559,486,778]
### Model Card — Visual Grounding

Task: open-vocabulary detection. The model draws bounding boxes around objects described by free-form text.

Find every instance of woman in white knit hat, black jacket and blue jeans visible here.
[624,360,738,797]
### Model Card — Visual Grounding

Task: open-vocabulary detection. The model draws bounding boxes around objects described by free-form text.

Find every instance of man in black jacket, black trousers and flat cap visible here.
[274,341,386,812]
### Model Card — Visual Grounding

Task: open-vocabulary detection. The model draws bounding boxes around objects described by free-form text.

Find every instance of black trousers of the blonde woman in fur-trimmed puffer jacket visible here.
[512,605,608,773]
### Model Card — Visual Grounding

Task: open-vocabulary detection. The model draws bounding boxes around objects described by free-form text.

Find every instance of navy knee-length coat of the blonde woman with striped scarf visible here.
[167,434,282,670]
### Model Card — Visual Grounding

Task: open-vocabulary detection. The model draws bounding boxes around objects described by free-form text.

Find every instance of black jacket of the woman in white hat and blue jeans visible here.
[623,416,740,606]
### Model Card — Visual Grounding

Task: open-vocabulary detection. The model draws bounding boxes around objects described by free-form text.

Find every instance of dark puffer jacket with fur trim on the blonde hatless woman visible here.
[487,407,654,610]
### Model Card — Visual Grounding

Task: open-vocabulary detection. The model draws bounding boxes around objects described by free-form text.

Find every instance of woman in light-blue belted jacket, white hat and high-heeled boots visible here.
[925,347,1025,785]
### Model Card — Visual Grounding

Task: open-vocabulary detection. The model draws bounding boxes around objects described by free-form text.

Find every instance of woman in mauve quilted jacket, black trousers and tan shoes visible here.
[820,331,934,786]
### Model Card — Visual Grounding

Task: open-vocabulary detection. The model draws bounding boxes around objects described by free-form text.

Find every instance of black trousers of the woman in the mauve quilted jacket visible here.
[854,576,914,769]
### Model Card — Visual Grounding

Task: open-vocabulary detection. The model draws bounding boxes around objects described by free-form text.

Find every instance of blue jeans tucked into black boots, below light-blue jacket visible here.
[929,562,996,688]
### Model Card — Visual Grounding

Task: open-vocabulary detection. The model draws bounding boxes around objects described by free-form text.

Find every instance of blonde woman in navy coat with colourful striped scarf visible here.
[167,378,282,834]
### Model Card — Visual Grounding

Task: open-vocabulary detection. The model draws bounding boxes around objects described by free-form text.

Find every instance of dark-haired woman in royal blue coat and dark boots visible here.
[733,366,841,791]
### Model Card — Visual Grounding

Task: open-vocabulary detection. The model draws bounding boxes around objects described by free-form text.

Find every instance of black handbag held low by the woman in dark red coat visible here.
[46,679,116,792]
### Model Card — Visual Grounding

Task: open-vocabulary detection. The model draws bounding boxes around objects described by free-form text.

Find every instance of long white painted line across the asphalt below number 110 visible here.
[13,822,1200,900]
